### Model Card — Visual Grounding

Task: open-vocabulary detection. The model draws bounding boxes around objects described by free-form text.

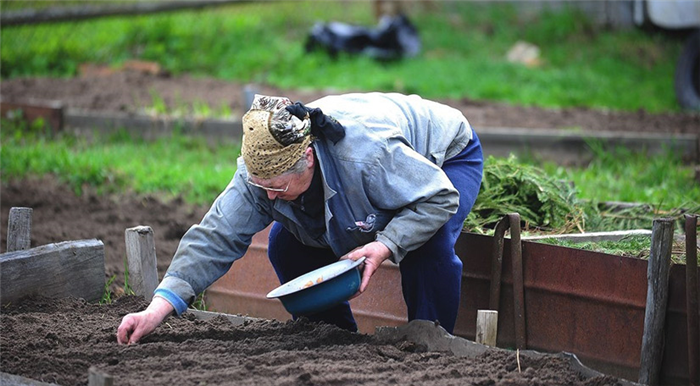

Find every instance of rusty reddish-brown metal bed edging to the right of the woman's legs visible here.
[455,233,688,385]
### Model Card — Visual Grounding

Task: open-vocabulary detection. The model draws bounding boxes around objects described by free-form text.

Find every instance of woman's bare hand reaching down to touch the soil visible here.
[117,296,175,344]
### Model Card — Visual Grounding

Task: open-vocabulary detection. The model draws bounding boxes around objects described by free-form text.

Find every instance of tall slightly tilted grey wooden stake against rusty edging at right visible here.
[639,219,673,385]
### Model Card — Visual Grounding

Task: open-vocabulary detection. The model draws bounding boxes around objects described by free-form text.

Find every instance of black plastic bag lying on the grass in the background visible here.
[306,15,421,60]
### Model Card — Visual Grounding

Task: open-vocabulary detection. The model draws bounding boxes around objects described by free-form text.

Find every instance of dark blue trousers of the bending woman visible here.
[268,133,483,333]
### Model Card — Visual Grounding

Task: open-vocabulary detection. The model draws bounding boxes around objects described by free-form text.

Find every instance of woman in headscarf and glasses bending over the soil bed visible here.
[117,93,483,343]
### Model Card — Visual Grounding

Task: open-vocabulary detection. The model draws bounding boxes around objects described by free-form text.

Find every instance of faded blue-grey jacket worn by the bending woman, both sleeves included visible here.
[156,93,472,314]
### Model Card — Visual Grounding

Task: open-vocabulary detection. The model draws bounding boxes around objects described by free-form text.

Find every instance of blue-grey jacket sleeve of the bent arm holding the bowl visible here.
[368,141,459,263]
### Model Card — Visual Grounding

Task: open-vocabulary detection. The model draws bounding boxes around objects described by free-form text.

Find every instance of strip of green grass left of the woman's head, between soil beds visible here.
[0,113,240,204]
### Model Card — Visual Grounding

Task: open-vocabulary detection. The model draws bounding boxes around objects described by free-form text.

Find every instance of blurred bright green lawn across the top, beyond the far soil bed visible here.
[0,0,682,112]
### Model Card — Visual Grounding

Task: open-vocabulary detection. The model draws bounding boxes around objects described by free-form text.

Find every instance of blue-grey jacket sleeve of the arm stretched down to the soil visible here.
[155,162,272,315]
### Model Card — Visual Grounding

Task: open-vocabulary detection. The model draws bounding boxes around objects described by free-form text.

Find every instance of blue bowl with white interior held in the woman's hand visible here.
[267,257,365,316]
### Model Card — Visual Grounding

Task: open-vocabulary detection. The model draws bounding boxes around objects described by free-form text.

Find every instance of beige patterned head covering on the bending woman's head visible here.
[241,95,313,179]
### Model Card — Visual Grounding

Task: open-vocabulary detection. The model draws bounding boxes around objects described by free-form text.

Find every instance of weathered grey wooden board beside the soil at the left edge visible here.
[0,239,105,304]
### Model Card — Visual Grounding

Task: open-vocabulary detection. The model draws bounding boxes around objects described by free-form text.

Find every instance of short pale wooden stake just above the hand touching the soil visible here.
[124,226,158,301]
